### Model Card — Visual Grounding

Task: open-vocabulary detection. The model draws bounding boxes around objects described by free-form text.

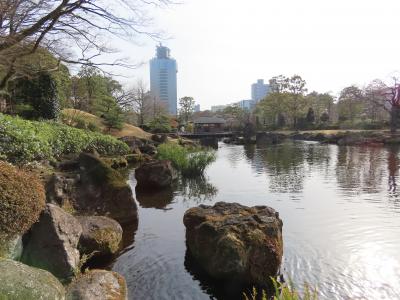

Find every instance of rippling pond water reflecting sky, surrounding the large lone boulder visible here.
[113,142,400,300]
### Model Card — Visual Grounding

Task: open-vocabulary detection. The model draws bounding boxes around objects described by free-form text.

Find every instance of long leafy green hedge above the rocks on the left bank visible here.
[0,114,129,162]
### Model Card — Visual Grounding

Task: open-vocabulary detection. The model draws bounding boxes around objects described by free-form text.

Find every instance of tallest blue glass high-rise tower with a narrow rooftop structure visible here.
[150,44,178,115]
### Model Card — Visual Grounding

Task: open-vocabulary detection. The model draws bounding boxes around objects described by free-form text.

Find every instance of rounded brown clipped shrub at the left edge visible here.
[0,161,46,240]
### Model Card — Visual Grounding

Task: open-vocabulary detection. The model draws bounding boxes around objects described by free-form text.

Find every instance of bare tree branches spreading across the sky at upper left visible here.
[0,0,169,90]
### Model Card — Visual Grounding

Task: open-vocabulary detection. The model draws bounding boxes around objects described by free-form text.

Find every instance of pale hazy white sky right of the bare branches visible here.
[111,0,400,109]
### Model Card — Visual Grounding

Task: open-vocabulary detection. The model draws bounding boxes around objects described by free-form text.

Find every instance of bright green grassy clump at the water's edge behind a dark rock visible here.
[157,143,216,177]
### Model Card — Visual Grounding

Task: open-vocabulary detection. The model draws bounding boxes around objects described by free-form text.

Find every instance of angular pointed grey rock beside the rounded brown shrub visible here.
[22,203,82,281]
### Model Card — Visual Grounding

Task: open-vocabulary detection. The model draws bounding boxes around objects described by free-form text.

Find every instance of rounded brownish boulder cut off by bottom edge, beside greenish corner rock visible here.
[66,270,128,300]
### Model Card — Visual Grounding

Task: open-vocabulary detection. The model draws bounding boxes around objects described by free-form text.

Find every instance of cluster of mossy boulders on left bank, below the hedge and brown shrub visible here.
[0,153,137,300]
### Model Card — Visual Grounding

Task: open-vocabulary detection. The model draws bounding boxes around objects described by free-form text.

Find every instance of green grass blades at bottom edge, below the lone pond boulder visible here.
[244,278,318,300]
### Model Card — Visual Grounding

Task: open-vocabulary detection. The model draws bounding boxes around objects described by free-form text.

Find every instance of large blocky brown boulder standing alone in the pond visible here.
[183,202,283,285]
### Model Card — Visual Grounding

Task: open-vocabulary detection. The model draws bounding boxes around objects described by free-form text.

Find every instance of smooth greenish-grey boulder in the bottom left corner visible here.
[0,259,65,300]
